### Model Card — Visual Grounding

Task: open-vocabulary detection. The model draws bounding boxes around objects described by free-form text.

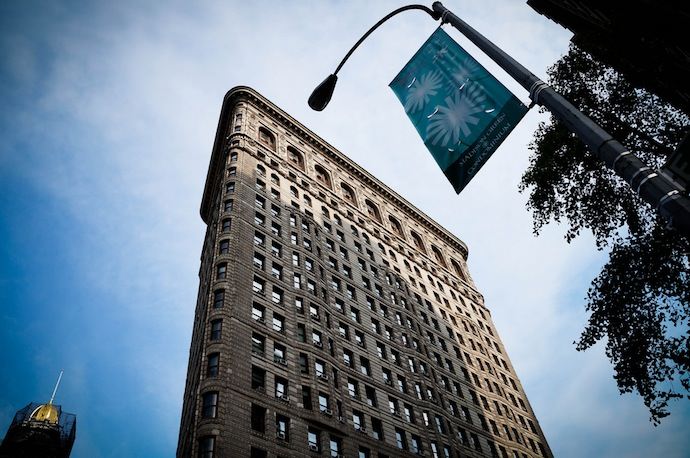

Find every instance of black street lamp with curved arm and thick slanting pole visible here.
[309,2,690,238]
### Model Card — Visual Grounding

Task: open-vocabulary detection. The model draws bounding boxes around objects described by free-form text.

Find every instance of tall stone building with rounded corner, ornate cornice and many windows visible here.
[177,87,552,458]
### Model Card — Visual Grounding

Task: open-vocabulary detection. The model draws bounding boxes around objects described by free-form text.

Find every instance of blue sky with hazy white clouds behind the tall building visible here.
[0,0,690,458]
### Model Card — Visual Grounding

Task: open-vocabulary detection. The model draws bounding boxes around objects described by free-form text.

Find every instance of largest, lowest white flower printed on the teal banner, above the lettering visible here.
[426,84,486,147]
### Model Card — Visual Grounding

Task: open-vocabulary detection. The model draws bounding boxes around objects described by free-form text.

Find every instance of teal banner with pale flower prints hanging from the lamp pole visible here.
[390,27,527,194]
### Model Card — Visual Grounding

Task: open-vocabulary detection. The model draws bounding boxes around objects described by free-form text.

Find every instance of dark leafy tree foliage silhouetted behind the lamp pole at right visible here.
[520,45,690,424]
